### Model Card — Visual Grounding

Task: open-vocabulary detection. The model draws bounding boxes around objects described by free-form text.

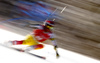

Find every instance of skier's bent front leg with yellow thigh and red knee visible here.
[22,35,44,51]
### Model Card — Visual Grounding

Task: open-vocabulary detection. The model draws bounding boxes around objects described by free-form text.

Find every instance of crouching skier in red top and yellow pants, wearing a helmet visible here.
[8,20,59,56]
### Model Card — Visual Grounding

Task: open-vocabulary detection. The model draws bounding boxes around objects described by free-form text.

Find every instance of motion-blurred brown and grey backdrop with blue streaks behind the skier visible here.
[0,0,100,60]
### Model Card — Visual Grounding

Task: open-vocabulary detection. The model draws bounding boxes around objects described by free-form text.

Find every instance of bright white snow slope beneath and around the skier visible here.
[0,29,100,63]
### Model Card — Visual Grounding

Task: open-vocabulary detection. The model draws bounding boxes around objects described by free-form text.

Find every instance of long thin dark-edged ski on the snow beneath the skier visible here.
[0,43,46,60]
